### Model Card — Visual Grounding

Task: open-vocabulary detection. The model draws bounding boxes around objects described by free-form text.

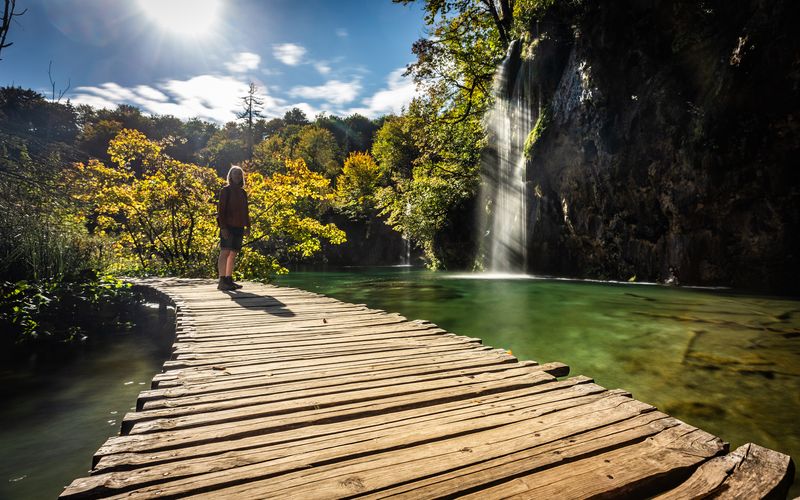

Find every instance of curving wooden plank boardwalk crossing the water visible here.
[61,279,793,499]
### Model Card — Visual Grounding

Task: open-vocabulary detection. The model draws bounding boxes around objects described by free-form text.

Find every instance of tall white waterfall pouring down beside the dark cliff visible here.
[481,40,538,273]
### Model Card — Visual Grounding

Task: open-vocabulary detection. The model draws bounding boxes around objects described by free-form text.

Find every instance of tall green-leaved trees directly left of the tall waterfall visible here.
[373,0,553,267]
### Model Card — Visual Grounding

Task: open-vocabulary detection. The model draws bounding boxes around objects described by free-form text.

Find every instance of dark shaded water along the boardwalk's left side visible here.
[0,305,175,500]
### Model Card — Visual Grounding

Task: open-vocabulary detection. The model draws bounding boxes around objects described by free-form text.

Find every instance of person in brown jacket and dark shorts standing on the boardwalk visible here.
[217,165,250,290]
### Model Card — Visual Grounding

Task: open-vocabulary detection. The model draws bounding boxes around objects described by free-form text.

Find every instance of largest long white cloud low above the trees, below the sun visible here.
[71,75,287,123]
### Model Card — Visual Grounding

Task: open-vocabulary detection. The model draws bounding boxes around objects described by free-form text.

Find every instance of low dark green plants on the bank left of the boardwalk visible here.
[0,274,137,358]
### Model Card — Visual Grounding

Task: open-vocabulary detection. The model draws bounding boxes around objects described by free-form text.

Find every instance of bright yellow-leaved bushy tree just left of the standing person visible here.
[65,129,222,276]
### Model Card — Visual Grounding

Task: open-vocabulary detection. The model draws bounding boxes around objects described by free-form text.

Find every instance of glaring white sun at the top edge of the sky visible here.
[137,0,222,38]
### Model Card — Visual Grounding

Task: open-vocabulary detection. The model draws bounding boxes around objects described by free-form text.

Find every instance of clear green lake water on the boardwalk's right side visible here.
[278,268,800,496]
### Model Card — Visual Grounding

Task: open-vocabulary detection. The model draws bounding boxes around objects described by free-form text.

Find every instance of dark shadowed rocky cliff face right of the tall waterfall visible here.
[520,0,800,292]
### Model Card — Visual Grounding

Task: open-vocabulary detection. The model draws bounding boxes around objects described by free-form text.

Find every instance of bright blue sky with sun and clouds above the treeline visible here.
[0,0,424,123]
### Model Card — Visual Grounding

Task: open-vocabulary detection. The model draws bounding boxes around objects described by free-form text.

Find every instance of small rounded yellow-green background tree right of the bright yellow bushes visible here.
[336,153,383,219]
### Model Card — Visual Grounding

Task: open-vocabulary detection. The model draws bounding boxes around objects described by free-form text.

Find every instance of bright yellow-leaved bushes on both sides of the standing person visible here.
[65,130,345,279]
